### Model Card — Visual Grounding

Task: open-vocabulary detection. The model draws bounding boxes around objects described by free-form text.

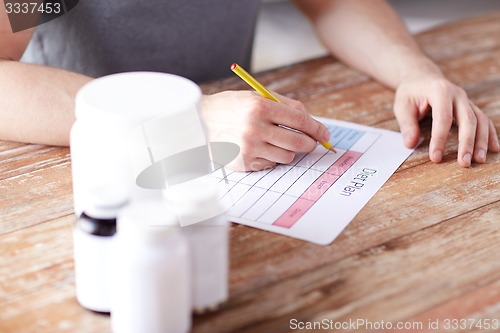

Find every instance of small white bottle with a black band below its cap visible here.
[73,185,128,312]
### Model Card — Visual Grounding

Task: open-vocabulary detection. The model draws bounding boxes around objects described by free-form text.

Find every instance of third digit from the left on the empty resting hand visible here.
[455,98,478,167]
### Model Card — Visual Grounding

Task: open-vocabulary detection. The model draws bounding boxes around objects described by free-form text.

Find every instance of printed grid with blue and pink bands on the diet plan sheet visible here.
[212,126,380,228]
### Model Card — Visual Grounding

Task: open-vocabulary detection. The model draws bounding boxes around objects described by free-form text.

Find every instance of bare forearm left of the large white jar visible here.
[0,60,91,146]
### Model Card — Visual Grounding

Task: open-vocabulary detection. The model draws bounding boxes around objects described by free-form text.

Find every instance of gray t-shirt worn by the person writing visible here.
[23,0,260,82]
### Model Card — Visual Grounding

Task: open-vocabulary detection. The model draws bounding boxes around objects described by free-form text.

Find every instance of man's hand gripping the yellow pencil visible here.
[202,91,330,171]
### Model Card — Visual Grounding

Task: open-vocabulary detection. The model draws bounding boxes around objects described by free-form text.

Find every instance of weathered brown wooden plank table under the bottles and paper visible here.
[0,13,500,333]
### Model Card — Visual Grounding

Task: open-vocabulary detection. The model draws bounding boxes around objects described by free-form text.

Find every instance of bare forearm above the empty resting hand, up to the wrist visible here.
[296,0,442,88]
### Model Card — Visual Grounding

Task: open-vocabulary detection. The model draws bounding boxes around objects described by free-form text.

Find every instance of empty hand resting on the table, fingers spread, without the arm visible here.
[394,74,500,167]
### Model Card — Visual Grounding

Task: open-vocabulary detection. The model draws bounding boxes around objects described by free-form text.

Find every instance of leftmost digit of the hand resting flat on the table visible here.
[394,92,420,148]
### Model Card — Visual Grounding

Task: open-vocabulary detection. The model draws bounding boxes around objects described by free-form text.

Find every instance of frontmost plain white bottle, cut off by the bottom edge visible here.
[111,201,191,333]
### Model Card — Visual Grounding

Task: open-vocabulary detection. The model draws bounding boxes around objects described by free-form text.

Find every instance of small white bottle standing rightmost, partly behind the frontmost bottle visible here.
[164,176,229,313]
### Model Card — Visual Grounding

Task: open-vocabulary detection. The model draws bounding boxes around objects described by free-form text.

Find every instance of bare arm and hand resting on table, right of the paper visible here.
[295,0,500,167]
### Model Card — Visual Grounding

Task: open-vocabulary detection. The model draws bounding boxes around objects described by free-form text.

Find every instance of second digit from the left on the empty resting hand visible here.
[429,97,453,162]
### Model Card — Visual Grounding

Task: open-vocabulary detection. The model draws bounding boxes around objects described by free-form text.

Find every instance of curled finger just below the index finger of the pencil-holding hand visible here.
[264,126,317,152]
